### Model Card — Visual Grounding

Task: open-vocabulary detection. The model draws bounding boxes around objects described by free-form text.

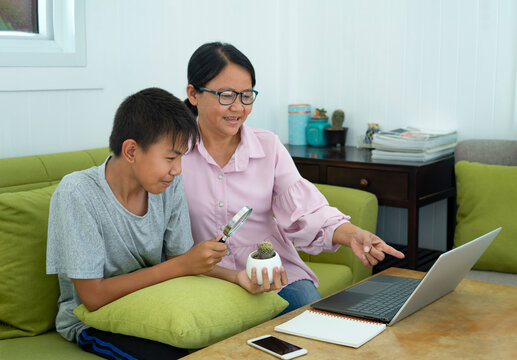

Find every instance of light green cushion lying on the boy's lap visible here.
[74,276,288,349]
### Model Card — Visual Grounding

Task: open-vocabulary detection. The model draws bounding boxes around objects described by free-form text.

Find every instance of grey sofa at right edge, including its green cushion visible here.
[454,139,517,285]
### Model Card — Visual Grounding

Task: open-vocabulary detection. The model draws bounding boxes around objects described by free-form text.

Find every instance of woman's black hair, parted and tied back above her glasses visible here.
[185,42,255,115]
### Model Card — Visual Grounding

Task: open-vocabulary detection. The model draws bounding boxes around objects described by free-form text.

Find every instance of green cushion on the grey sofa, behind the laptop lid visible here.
[454,161,517,273]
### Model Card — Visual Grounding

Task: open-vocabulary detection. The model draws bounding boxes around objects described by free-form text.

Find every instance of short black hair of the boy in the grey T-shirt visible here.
[109,88,199,156]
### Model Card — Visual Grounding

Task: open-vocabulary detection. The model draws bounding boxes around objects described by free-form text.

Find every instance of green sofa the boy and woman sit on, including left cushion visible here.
[0,148,377,360]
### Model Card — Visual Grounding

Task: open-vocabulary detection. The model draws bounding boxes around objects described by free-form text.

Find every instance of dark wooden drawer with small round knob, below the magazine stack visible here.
[327,166,408,201]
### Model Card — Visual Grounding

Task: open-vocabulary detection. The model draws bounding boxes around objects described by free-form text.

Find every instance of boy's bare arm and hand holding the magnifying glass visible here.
[72,239,226,311]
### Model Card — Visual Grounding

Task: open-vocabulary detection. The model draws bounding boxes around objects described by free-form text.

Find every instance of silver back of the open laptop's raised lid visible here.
[388,227,501,326]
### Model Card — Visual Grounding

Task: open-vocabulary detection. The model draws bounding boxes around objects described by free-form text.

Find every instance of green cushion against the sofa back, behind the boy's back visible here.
[0,185,59,339]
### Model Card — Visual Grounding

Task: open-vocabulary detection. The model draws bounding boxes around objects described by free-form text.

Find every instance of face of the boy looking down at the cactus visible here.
[133,136,187,194]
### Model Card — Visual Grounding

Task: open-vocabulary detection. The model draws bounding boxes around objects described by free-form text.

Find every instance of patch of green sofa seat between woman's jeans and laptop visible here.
[306,261,354,297]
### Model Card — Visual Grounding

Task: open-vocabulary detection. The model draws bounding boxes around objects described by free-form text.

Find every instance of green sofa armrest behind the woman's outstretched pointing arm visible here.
[299,184,378,283]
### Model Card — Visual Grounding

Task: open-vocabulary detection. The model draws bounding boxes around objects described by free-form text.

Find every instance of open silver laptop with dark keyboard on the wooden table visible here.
[311,227,501,326]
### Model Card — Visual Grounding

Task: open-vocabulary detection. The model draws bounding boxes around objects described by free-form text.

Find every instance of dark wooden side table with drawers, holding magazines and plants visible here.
[286,145,456,269]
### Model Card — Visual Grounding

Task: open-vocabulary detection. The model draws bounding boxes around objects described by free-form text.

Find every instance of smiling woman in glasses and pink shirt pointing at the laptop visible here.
[182,43,404,312]
